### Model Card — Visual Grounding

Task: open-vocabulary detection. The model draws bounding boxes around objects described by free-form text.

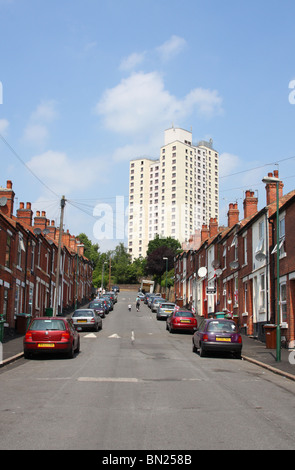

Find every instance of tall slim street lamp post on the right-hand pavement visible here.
[262,176,281,362]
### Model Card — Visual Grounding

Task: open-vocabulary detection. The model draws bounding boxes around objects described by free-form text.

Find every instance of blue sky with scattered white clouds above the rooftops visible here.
[0,0,295,252]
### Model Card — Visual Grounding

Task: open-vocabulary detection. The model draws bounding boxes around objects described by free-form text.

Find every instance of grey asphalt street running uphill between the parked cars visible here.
[0,292,295,451]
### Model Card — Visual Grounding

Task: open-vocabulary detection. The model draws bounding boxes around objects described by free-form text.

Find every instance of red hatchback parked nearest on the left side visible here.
[24,317,80,359]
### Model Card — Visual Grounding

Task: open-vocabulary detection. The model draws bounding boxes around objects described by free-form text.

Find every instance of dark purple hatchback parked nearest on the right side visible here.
[192,318,242,358]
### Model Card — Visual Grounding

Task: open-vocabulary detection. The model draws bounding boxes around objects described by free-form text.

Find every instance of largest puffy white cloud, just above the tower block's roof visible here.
[96,72,222,136]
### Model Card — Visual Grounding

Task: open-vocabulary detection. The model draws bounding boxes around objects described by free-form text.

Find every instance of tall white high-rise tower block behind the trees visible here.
[128,127,219,259]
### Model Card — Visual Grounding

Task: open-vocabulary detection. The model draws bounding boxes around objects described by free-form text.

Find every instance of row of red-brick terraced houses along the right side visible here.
[175,171,295,348]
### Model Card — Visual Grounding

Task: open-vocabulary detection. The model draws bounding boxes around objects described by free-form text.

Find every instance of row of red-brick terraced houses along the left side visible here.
[0,181,93,328]
